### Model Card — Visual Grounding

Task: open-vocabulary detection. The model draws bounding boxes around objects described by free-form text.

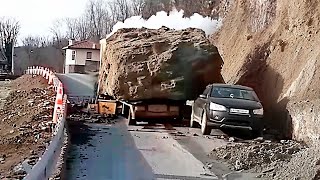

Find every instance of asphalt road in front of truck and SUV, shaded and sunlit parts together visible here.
[66,118,255,180]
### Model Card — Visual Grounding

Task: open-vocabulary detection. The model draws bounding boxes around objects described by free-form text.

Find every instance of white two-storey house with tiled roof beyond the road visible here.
[63,40,100,73]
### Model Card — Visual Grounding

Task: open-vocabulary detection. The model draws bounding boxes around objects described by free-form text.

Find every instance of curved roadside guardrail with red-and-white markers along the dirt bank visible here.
[24,66,67,180]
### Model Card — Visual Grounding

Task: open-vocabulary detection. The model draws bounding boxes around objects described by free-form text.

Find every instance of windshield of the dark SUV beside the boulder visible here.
[211,87,259,101]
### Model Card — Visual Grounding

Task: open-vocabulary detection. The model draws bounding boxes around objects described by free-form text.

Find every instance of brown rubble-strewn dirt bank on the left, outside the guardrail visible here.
[0,75,55,179]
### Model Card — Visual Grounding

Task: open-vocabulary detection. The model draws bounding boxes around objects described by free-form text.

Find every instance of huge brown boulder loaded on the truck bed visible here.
[99,27,223,100]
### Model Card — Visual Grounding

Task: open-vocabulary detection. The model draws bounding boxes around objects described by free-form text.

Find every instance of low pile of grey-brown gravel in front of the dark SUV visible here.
[210,140,306,172]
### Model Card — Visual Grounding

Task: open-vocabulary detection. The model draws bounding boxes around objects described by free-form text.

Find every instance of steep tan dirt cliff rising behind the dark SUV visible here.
[212,0,320,144]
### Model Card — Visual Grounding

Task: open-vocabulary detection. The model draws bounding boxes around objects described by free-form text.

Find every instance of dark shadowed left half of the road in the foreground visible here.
[65,120,154,180]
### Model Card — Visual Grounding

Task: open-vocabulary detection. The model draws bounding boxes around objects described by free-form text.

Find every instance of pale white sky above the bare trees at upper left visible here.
[0,0,88,39]
